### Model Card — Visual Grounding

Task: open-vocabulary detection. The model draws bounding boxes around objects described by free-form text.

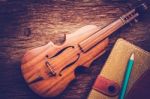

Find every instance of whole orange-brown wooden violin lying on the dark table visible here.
[21,3,147,97]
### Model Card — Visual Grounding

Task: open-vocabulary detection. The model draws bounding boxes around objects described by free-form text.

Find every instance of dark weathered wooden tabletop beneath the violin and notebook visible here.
[0,0,150,99]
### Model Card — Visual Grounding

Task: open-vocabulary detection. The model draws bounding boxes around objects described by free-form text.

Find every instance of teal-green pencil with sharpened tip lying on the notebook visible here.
[119,53,134,99]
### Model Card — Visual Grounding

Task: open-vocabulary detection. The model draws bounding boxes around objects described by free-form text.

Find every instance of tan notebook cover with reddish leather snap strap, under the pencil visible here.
[88,39,150,99]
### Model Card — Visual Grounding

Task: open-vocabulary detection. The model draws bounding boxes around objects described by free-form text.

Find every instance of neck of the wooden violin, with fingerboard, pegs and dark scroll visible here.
[79,3,147,52]
